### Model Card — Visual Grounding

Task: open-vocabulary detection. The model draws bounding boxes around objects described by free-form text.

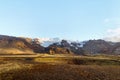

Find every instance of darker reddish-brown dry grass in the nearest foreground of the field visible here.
[0,64,120,80]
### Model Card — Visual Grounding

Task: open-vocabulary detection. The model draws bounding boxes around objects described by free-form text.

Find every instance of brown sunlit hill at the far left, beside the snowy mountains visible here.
[0,35,42,54]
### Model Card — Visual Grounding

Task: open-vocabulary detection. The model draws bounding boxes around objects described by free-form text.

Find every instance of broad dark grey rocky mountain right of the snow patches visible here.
[83,40,112,54]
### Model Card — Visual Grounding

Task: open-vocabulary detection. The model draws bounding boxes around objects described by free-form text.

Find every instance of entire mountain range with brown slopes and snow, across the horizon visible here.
[0,35,120,55]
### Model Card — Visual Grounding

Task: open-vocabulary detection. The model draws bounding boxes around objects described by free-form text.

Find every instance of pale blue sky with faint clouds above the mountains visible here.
[0,0,120,41]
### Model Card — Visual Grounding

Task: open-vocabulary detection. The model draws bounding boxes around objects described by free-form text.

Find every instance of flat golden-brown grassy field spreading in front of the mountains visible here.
[0,54,120,80]
